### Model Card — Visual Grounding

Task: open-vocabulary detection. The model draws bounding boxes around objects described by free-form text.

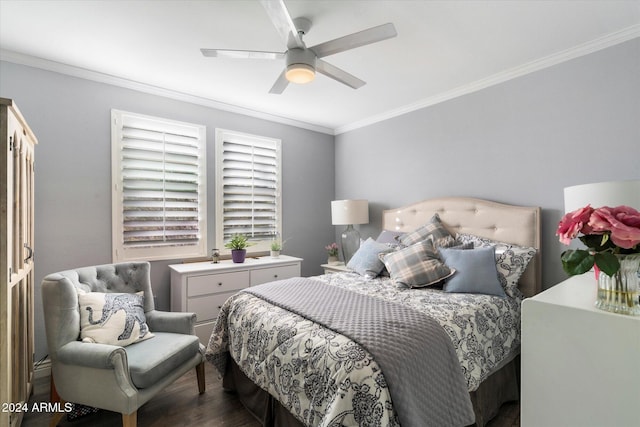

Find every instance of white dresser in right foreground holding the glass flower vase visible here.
[520,272,640,427]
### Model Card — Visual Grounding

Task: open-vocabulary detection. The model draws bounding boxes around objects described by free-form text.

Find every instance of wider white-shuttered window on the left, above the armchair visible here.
[111,110,207,261]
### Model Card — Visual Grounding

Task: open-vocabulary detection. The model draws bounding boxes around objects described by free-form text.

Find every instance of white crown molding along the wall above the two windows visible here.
[0,49,333,135]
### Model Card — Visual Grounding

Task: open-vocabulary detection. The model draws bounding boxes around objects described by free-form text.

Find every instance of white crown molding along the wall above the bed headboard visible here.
[334,24,640,135]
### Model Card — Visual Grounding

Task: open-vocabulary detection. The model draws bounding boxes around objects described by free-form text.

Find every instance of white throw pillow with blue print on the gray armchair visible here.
[78,289,153,347]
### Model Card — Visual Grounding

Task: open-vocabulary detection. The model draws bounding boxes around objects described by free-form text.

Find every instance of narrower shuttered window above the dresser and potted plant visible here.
[216,129,282,252]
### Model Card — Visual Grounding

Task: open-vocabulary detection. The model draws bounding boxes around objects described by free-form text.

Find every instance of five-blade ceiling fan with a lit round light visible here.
[200,0,398,94]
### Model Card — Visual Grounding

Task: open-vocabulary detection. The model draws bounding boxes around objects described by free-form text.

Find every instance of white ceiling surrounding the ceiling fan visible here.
[0,0,640,133]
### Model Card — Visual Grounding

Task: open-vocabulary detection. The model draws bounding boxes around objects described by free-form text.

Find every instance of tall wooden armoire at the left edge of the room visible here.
[0,98,37,427]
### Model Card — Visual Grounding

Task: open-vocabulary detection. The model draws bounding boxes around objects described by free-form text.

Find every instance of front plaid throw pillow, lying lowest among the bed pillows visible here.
[382,240,455,288]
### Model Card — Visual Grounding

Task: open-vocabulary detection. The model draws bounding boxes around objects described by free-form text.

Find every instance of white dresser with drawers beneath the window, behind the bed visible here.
[169,255,302,346]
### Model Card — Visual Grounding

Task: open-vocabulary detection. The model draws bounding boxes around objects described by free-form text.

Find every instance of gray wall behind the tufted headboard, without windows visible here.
[336,39,640,288]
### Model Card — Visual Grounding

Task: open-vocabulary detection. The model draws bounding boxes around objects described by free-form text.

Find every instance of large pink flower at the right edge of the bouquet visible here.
[589,206,640,249]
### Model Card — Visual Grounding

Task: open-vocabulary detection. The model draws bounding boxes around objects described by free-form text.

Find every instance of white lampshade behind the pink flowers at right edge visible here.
[564,180,640,213]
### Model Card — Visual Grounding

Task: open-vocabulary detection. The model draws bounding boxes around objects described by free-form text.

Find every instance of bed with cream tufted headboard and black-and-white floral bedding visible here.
[206,198,541,427]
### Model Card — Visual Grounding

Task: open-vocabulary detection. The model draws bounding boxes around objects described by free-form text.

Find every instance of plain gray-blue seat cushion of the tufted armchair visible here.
[125,332,200,388]
